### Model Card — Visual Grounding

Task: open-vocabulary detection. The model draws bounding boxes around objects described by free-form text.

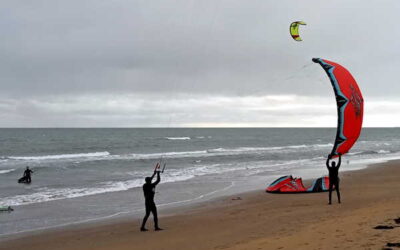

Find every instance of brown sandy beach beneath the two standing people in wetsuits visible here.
[0,161,400,250]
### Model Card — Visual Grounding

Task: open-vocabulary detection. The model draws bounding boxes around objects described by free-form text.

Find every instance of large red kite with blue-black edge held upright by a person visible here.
[312,58,364,158]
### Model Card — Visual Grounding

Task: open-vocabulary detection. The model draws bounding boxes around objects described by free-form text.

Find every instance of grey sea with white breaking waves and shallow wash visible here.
[0,128,400,236]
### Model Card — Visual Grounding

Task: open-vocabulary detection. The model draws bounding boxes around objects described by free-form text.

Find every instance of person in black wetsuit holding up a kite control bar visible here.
[140,163,162,231]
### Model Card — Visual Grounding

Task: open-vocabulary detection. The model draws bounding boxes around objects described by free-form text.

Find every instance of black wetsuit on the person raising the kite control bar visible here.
[141,172,160,229]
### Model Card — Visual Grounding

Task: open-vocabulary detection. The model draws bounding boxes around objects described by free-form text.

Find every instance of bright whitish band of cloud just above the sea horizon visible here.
[0,94,400,127]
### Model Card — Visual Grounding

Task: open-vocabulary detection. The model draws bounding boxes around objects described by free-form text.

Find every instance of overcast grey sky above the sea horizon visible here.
[0,0,400,127]
